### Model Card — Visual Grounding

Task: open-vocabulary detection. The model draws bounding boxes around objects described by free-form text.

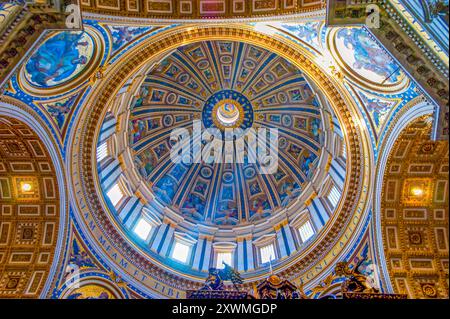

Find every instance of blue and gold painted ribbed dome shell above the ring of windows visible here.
[129,41,325,225]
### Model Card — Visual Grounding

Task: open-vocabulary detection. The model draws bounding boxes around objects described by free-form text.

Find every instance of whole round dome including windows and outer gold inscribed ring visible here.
[65,22,369,293]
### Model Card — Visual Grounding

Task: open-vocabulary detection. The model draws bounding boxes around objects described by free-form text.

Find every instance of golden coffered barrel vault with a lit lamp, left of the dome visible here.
[0,117,60,298]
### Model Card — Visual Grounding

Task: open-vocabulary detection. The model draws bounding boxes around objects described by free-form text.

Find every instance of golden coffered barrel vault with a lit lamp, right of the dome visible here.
[381,117,449,298]
